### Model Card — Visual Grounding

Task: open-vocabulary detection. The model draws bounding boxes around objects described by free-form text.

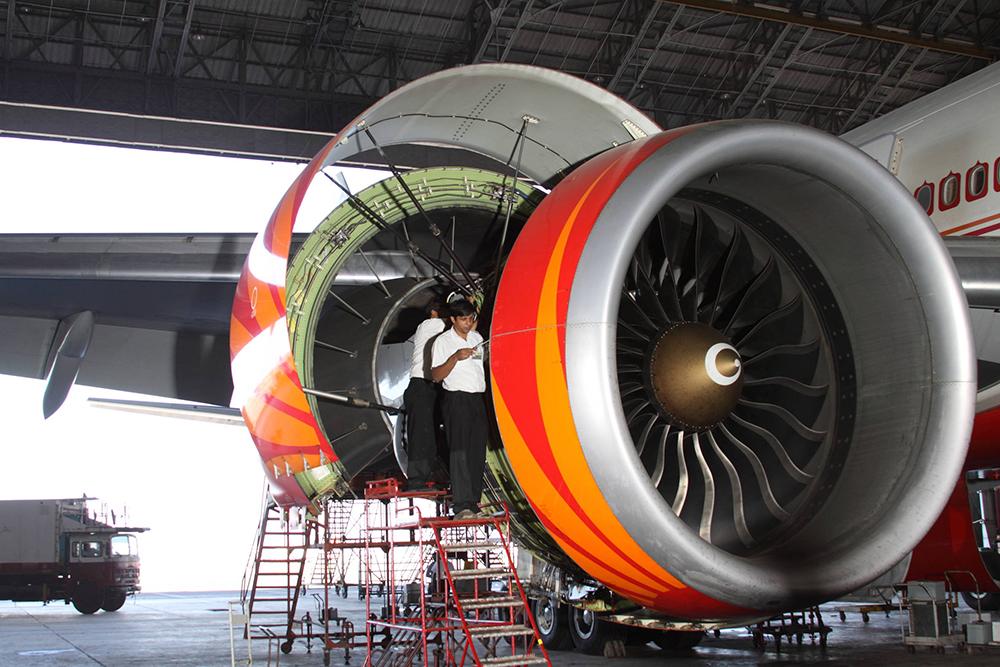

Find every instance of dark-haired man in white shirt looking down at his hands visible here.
[431,299,487,519]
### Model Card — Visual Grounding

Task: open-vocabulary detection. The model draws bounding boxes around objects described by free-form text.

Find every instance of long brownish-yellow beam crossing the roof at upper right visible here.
[661,0,1000,62]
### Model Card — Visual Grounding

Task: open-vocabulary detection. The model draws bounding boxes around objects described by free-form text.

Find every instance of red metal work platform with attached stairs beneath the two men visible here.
[364,479,551,667]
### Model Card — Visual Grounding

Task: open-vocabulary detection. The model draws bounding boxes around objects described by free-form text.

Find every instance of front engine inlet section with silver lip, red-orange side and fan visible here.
[491,122,975,620]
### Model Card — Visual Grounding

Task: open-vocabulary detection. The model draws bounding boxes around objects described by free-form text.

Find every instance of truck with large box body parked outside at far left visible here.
[0,497,148,614]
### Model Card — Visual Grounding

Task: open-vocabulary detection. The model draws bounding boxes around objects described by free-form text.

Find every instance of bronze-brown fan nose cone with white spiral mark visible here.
[648,322,743,430]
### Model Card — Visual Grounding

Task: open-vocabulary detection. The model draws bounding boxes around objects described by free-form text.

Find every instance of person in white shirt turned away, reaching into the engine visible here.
[403,297,447,491]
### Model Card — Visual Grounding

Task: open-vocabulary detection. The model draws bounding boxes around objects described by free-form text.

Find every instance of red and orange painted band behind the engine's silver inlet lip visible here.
[491,130,754,618]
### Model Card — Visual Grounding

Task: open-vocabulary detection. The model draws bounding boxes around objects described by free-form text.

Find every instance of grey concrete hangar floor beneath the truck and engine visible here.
[0,593,1000,667]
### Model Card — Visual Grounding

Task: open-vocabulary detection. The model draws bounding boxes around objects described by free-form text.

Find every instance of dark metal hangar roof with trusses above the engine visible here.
[0,0,1000,151]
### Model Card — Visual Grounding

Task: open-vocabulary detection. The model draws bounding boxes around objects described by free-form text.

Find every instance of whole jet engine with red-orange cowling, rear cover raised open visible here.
[232,65,975,622]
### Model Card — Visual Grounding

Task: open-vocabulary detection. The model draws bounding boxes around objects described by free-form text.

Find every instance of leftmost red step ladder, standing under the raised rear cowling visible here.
[243,501,315,652]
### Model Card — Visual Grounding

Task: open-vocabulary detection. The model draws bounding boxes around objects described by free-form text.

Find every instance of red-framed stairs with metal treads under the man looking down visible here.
[429,508,552,665]
